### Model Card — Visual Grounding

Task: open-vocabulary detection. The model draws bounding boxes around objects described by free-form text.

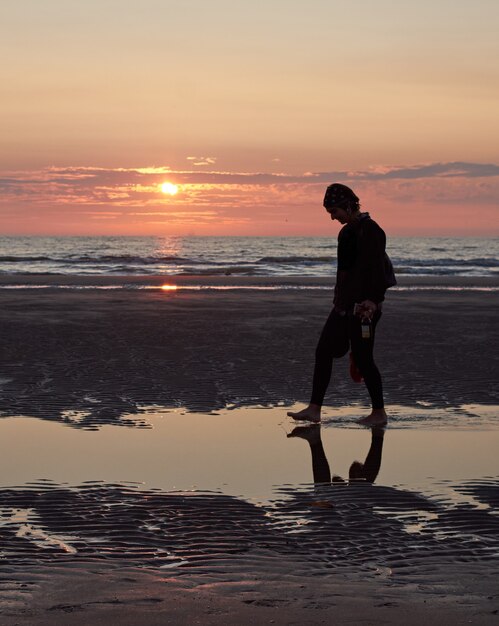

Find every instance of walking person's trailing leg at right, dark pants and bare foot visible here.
[348,311,387,425]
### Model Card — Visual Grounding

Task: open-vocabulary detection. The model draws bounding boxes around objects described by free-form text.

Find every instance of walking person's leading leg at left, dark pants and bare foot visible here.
[288,310,349,422]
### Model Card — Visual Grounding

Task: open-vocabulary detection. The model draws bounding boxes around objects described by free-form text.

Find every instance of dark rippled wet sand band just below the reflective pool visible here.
[0,478,499,580]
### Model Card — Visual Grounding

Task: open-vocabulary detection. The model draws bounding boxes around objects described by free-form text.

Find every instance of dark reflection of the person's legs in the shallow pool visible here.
[288,424,385,483]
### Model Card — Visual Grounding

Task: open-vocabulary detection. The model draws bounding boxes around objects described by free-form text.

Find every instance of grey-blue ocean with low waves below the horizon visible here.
[0,237,499,277]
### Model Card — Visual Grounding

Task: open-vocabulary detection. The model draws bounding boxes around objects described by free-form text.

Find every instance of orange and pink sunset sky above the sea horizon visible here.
[0,0,499,236]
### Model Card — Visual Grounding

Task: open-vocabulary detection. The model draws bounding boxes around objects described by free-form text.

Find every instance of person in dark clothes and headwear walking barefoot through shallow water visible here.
[288,183,395,425]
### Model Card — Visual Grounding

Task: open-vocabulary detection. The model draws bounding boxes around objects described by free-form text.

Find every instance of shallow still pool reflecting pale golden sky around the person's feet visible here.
[0,407,499,500]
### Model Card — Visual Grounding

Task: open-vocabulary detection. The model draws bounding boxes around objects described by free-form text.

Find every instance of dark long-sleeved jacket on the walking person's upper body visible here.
[334,213,395,312]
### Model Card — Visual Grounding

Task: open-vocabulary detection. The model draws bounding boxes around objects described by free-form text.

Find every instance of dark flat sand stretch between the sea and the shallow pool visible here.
[0,290,499,429]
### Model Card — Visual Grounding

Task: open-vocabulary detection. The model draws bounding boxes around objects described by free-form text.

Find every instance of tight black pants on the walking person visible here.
[310,310,384,409]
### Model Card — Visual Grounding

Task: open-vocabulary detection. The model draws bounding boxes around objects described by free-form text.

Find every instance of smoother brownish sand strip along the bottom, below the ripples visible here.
[2,567,498,626]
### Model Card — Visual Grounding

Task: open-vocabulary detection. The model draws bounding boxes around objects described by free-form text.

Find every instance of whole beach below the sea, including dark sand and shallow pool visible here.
[0,276,499,626]
